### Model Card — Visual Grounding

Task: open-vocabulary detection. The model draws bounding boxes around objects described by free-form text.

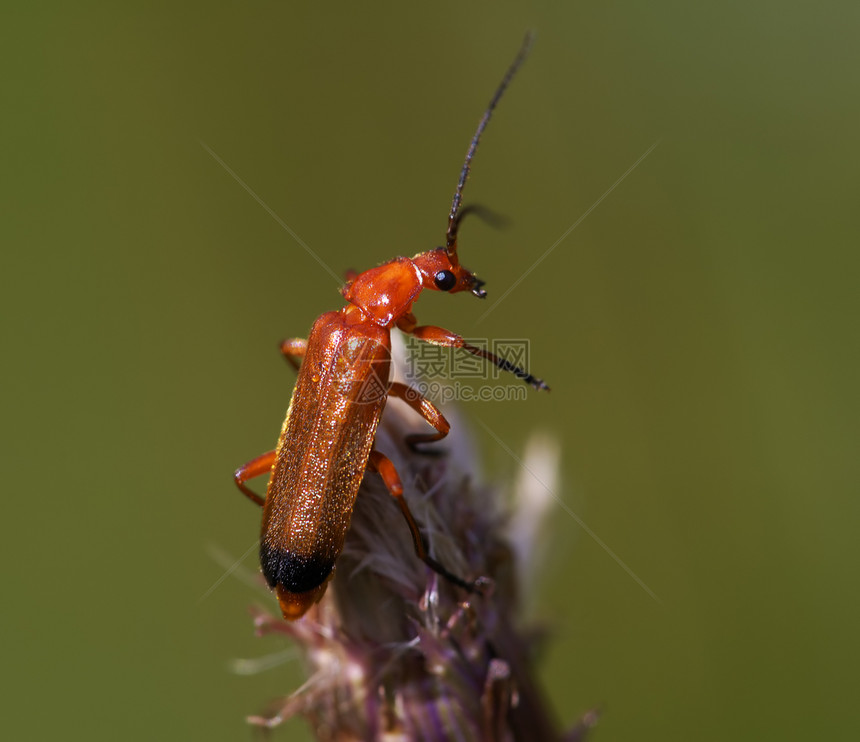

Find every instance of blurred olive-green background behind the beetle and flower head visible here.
[0,2,860,741]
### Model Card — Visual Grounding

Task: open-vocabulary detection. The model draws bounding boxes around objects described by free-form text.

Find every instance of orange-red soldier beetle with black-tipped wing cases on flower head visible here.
[234,36,549,620]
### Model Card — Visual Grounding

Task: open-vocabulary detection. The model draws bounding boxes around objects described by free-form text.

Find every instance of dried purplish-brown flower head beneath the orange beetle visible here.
[239,370,596,742]
